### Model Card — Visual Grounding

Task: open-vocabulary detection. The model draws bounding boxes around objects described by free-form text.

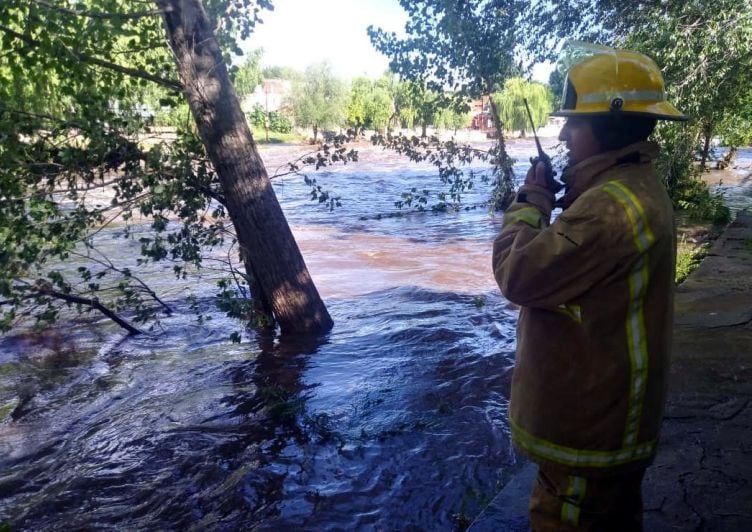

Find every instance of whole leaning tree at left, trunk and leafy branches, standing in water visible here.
[0,0,334,333]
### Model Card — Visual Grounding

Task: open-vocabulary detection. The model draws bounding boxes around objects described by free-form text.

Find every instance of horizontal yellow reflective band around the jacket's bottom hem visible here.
[509,417,656,467]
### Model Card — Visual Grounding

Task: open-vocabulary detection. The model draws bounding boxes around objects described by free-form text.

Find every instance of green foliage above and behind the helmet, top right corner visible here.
[528,0,752,218]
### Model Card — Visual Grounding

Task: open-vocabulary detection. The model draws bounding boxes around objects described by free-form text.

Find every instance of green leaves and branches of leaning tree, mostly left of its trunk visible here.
[0,0,350,336]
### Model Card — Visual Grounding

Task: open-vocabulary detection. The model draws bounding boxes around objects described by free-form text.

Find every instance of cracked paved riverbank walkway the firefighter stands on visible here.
[470,213,752,532]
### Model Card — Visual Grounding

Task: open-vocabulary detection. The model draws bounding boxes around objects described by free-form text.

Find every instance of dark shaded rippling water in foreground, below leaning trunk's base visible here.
[0,287,515,530]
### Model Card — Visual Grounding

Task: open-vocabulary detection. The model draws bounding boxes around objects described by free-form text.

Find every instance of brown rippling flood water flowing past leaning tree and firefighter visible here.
[0,141,752,530]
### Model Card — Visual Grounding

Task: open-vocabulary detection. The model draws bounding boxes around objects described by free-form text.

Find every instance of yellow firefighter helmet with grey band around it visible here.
[551,42,688,120]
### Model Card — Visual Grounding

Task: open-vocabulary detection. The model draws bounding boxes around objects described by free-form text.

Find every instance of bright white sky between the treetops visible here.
[243,0,550,82]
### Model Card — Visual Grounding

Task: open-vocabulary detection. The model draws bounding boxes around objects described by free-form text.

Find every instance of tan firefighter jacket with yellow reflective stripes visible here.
[493,142,676,475]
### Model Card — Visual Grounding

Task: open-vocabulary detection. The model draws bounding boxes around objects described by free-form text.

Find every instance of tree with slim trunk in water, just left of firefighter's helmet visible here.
[369,0,530,207]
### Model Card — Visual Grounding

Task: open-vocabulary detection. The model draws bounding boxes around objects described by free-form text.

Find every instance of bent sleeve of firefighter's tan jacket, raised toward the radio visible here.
[493,187,637,308]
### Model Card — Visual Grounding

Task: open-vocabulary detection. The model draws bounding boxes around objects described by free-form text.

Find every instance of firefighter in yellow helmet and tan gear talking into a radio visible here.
[493,42,687,531]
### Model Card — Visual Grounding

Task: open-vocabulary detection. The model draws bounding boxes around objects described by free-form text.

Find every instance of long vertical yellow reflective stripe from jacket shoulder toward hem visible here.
[603,181,655,447]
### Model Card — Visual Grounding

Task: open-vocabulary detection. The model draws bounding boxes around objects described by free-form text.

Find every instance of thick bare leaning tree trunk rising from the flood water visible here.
[155,0,332,333]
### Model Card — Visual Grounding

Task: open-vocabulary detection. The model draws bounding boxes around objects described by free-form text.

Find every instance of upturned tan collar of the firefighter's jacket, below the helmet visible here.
[559,142,659,208]
